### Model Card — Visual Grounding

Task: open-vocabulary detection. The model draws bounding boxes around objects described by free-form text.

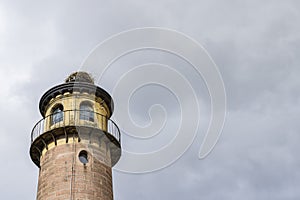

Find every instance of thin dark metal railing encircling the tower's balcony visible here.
[31,110,121,143]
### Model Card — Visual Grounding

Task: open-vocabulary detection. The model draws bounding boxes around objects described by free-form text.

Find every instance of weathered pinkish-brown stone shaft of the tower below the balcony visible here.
[37,139,113,200]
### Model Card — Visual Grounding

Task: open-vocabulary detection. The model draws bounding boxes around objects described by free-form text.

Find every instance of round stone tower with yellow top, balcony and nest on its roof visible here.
[30,72,121,200]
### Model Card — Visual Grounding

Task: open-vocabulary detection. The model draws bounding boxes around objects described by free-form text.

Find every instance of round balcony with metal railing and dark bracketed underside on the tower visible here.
[30,110,121,166]
